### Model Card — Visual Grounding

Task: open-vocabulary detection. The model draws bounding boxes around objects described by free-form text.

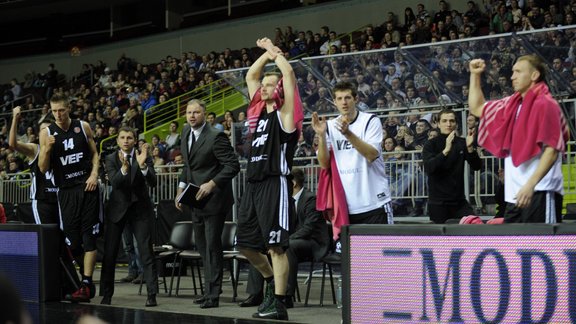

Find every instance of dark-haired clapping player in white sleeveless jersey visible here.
[312,82,394,233]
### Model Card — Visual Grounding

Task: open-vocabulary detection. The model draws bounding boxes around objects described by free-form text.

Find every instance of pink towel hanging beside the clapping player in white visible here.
[316,150,350,241]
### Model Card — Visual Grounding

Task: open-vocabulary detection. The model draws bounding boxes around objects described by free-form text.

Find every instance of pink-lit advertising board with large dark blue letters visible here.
[349,235,576,323]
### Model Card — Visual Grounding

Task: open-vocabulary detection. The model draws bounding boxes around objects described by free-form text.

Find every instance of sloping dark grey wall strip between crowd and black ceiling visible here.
[0,0,467,83]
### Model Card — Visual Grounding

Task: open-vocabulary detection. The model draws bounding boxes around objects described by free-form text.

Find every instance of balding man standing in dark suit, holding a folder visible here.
[175,99,240,308]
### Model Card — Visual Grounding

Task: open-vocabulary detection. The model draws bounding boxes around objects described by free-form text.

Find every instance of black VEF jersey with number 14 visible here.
[48,119,92,188]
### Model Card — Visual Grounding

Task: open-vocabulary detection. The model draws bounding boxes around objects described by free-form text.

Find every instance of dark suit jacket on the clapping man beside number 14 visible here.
[106,151,156,223]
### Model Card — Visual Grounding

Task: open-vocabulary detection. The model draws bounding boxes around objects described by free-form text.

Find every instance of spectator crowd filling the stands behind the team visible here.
[0,0,576,213]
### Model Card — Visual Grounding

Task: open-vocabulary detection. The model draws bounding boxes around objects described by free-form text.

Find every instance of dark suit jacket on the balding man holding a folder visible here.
[179,123,240,215]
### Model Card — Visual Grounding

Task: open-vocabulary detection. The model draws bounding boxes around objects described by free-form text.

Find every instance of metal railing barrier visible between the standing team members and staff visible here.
[0,151,576,216]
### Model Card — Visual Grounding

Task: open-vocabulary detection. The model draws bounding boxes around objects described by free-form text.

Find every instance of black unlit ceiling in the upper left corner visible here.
[0,0,310,59]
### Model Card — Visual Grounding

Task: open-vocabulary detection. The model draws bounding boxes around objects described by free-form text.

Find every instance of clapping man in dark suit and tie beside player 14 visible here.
[100,127,158,307]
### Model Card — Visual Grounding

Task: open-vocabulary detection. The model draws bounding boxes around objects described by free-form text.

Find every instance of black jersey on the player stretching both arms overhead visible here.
[246,110,298,182]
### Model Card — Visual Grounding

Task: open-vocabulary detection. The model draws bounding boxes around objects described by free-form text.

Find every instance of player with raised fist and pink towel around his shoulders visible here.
[468,54,569,223]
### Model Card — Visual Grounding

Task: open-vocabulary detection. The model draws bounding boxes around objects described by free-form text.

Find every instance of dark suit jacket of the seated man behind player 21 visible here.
[290,189,330,260]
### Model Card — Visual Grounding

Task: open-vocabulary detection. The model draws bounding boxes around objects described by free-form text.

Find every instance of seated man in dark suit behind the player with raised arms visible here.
[239,168,330,308]
